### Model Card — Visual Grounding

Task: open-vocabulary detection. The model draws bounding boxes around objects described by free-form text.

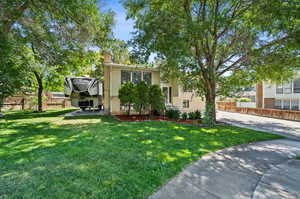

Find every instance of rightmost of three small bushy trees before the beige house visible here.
[149,84,165,114]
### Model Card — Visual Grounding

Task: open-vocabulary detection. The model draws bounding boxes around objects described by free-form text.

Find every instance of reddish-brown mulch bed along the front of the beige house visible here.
[115,115,201,125]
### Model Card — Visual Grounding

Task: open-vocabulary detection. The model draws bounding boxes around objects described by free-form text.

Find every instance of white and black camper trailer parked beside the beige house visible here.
[64,77,103,111]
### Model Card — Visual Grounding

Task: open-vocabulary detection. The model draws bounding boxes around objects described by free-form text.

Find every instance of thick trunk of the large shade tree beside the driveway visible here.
[204,82,217,126]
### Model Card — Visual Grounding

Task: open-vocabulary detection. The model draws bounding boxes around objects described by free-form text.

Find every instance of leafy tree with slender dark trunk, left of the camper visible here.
[0,0,113,111]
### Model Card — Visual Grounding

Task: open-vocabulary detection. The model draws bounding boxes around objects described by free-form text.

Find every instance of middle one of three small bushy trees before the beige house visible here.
[133,81,149,115]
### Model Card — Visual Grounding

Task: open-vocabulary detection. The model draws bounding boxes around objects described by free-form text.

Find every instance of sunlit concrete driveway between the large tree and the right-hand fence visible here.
[217,111,300,141]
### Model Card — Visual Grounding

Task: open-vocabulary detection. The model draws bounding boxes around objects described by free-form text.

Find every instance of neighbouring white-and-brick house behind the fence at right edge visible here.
[256,73,300,110]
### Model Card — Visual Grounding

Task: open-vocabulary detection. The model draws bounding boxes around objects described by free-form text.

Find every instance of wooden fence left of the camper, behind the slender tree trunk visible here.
[0,94,71,111]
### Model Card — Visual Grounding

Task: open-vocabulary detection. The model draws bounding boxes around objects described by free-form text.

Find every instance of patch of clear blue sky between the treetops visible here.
[99,0,134,41]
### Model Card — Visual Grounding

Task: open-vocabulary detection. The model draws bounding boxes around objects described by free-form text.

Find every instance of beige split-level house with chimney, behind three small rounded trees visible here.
[103,54,204,115]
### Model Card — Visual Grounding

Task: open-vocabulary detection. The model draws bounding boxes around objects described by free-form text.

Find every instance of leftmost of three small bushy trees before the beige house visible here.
[119,82,136,115]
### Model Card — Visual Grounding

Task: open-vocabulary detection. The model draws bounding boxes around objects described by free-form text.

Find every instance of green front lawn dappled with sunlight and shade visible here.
[0,110,280,199]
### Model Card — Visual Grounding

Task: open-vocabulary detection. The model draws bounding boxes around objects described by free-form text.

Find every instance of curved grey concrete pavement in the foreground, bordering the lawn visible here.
[149,139,300,199]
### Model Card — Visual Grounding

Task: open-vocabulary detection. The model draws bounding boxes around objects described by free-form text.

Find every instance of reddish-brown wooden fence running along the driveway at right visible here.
[217,102,300,121]
